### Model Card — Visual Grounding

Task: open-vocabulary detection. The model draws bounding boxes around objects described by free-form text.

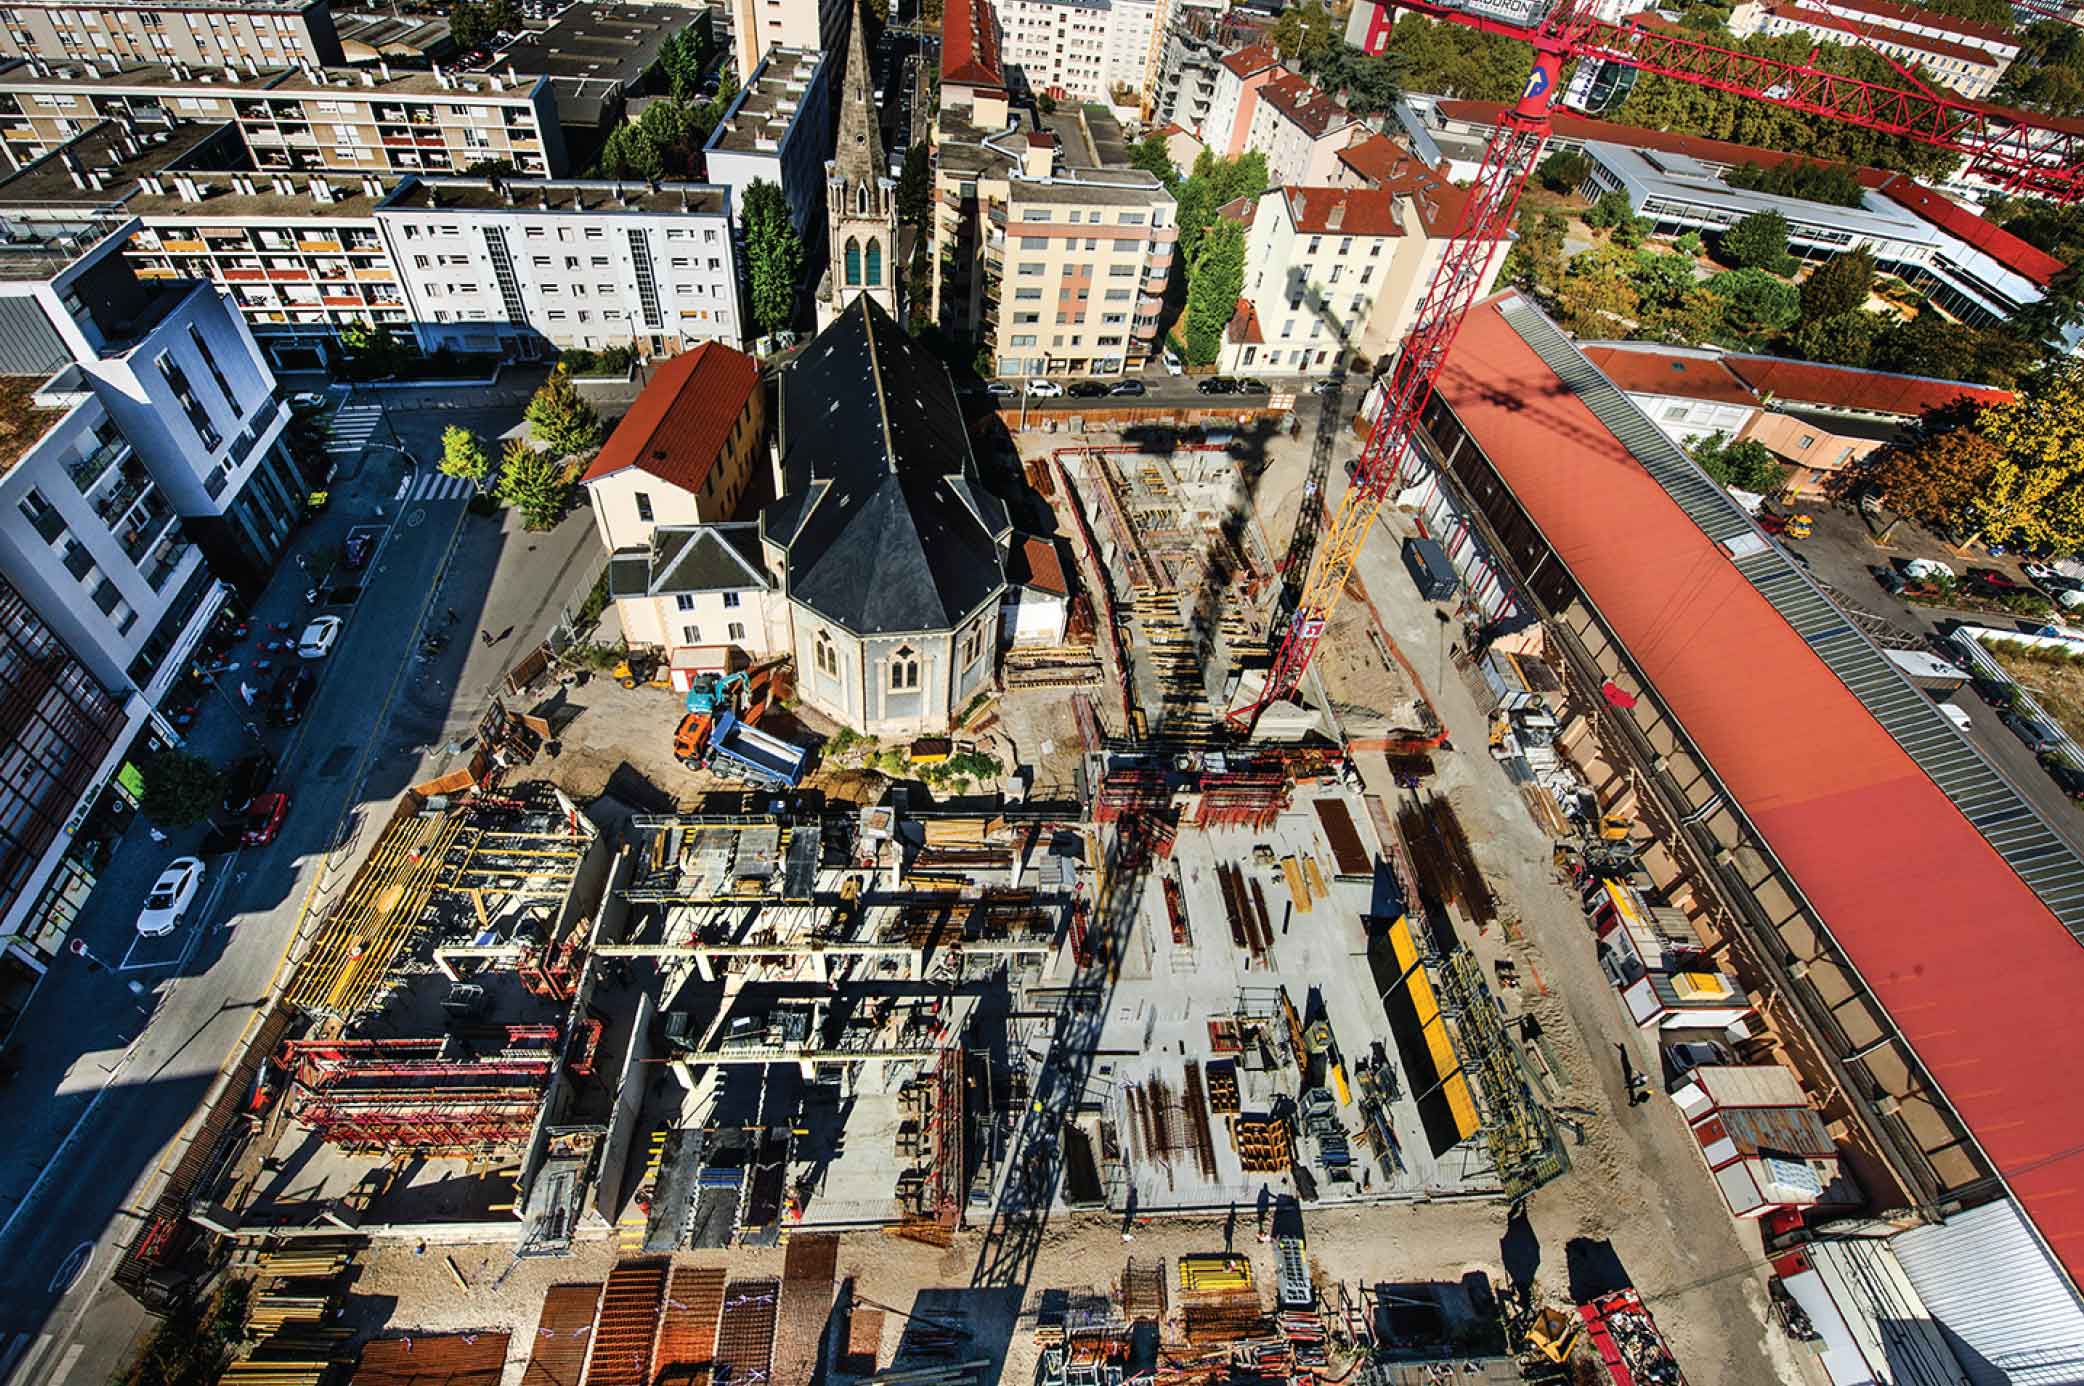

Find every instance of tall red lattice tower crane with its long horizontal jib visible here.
[1230,0,2084,732]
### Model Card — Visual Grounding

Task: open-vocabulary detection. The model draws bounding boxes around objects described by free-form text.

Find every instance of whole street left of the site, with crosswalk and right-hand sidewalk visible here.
[0,370,598,1386]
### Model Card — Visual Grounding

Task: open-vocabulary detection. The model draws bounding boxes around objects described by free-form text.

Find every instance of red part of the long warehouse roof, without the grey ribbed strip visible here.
[1440,296,2084,1282]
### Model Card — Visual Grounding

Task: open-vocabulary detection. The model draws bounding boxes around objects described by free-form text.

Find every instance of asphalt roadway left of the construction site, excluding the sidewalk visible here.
[0,385,477,1386]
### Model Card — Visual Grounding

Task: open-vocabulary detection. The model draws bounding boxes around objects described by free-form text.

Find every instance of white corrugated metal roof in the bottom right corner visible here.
[1890,1198,2084,1386]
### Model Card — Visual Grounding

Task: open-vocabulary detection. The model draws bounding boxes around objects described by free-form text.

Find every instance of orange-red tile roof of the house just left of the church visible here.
[579,342,761,494]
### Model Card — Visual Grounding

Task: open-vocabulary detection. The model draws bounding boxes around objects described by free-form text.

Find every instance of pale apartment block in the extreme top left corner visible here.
[0,0,342,67]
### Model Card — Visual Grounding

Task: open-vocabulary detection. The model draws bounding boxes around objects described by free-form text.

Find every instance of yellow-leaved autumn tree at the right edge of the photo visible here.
[1963,356,2084,552]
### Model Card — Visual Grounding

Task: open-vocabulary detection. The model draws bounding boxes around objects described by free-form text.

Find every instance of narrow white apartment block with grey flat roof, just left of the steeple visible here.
[702,48,836,240]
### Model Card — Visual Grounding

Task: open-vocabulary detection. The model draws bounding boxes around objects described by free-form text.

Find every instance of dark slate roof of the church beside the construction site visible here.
[761,294,1011,636]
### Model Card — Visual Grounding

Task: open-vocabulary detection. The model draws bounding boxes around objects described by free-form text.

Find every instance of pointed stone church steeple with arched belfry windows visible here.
[817,4,900,327]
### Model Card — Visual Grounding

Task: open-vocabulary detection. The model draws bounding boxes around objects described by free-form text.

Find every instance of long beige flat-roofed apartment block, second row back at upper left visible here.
[0,63,567,177]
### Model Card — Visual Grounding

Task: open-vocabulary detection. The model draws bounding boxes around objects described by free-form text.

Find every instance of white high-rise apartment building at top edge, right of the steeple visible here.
[998,0,1171,102]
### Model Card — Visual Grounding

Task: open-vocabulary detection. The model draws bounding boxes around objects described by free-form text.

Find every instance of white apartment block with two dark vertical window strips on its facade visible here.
[377,179,748,356]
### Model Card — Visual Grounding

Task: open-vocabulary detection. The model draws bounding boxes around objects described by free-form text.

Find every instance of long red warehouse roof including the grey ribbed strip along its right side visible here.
[1440,294,2084,1300]
